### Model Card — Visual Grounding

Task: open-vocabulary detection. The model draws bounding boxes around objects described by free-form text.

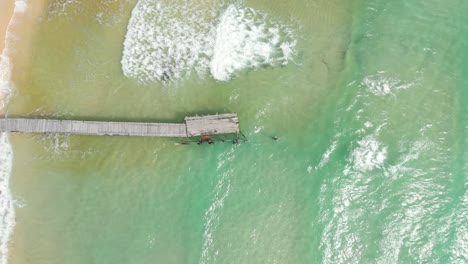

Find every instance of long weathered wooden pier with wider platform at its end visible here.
[0,113,241,138]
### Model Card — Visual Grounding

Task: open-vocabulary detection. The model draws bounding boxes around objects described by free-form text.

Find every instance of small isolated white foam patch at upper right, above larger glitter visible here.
[361,72,415,96]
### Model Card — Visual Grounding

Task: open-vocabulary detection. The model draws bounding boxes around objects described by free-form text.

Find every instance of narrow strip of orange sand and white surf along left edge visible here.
[0,0,46,264]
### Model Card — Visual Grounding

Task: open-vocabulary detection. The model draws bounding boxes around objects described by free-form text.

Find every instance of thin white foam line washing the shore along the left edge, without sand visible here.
[0,0,28,264]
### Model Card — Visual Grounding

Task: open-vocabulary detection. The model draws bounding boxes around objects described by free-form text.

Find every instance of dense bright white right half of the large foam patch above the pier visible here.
[210,5,296,81]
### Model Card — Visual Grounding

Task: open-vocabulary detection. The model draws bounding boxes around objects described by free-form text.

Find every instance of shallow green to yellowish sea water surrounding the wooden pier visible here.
[4,0,468,263]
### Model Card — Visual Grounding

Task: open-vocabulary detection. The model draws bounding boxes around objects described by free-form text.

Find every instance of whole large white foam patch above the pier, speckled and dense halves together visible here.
[121,0,296,83]
